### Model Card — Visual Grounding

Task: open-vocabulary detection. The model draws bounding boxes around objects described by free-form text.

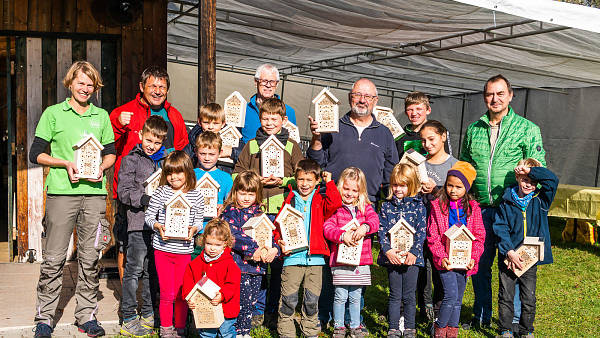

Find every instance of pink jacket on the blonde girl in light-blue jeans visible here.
[323,204,379,266]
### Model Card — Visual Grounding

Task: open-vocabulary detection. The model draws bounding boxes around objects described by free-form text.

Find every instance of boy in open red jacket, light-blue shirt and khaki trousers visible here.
[276,160,342,337]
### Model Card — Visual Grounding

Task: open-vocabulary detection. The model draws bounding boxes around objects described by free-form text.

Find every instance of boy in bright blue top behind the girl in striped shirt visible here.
[192,131,233,259]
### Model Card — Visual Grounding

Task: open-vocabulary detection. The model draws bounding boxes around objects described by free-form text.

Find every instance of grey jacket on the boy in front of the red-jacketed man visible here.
[117,144,158,232]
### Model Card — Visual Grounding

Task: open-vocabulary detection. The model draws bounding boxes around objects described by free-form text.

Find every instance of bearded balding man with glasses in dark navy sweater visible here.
[306,79,398,202]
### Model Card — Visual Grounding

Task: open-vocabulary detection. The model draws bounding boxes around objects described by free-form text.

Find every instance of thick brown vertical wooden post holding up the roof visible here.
[198,0,217,106]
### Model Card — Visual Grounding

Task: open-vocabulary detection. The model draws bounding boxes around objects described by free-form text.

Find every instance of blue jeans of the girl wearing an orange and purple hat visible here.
[437,270,467,327]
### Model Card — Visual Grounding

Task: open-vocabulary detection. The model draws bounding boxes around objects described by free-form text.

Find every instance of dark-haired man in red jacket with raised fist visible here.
[110,66,188,279]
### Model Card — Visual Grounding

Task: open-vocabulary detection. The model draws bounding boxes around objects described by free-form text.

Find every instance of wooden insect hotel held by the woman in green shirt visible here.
[73,134,104,179]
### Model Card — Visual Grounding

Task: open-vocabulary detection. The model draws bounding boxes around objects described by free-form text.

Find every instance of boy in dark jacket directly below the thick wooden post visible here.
[184,103,243,174]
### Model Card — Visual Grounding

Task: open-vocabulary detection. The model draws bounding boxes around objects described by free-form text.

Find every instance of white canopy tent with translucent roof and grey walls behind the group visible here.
[168,0,600,185]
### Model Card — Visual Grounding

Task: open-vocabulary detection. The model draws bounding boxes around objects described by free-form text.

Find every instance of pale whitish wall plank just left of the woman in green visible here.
[27,38,44,262]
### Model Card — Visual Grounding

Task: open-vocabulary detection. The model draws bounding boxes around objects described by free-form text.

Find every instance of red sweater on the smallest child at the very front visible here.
[182,248,242,318]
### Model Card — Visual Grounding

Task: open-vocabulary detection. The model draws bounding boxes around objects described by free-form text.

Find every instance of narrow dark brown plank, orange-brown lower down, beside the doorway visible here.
[15,38,29,262]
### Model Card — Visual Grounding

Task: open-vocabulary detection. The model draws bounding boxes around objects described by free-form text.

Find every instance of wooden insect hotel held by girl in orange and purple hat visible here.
[444,225,475,270]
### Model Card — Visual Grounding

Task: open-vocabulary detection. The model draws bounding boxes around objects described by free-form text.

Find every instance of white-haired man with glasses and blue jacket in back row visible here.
[242,63,296,143]
